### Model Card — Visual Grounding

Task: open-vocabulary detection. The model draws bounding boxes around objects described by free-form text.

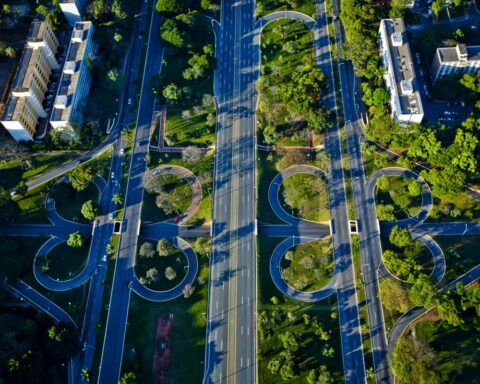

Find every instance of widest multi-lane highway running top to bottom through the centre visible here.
[203,0,257,384]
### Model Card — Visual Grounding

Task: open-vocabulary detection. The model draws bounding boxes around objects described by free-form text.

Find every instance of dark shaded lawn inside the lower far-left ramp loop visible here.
[40,239,91,280]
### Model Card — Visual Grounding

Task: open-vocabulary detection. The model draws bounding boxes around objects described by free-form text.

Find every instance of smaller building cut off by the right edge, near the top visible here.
[431,44,480,82]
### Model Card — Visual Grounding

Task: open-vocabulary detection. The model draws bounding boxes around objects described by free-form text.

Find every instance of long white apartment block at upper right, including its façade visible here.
[379,18,424,124]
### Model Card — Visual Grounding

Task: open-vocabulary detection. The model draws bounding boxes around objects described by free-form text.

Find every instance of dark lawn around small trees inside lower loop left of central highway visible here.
[135,238,187,291]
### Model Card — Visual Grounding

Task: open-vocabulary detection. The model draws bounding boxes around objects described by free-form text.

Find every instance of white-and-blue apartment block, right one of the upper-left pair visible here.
[50,21,95,133]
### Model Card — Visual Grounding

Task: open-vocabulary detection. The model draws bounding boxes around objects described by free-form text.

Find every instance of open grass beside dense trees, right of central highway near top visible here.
[257,20,316,146]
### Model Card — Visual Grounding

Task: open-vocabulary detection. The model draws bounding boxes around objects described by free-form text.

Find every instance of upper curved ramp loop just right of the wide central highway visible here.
[268,165,326,225]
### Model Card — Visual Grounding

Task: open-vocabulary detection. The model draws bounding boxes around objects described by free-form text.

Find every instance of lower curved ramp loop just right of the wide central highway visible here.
[270,237,336,303]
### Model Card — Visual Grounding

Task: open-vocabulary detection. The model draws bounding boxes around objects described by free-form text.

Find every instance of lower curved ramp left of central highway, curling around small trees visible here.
[132,237,198,302]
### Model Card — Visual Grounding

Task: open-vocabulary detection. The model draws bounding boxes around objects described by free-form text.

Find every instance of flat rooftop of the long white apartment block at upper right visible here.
[382,19,423,118]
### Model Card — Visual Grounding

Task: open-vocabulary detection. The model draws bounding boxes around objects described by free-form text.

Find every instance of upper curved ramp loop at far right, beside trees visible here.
[367,167,433,232]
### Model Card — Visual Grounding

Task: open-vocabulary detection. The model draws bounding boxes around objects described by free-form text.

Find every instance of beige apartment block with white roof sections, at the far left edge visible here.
[1,21,58,141]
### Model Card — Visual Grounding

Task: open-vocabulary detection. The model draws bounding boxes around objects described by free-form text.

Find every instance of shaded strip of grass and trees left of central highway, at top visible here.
[156,4,216,147]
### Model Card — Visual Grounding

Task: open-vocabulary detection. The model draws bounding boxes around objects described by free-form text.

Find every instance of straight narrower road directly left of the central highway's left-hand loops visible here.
[98,1,162,384]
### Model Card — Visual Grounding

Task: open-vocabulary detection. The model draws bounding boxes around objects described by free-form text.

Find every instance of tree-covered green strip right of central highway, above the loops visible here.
[257,20,331,147]
